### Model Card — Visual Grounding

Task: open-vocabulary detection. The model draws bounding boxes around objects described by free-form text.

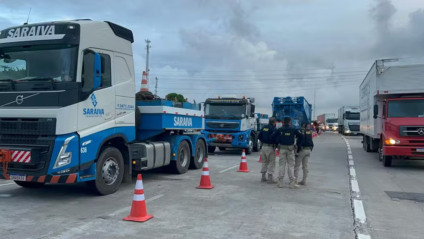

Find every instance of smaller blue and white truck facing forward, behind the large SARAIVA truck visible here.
[202,97,259,154]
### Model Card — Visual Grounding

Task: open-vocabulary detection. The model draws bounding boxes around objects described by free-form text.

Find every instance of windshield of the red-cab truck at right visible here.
[387,99,424,118]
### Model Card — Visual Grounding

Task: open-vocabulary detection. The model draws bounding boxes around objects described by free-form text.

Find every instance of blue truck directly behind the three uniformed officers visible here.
[272,96,312,129]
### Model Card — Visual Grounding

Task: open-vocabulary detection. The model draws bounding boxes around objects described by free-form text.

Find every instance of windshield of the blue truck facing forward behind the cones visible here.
[205,104,246,119]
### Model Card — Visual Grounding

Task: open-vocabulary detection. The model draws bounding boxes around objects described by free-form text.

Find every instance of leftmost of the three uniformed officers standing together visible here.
[259,117,277,184]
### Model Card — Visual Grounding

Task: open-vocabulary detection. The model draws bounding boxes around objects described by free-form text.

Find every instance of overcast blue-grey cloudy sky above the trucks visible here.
[0,0,424,115]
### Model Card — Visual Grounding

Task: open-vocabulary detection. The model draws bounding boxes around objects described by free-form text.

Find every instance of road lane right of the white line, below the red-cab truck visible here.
[347,137,424,239]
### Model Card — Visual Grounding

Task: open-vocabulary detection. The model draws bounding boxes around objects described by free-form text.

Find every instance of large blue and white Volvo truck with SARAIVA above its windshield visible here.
[0,20,207,195]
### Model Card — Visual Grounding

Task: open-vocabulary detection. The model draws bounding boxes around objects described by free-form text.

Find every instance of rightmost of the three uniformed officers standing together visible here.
[294,123,314,185]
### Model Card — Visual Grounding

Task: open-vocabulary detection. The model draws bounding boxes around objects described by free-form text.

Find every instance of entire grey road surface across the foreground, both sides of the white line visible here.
[0,133,424,239]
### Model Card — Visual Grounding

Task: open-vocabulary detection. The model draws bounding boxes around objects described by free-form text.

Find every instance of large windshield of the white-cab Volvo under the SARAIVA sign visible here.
[0,46,77,83]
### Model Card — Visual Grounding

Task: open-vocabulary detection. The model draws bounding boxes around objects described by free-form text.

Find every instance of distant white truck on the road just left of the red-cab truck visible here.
[338,106,360,135]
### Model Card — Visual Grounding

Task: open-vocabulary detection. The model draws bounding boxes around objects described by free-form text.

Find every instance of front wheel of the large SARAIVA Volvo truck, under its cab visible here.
[87,147,124,195]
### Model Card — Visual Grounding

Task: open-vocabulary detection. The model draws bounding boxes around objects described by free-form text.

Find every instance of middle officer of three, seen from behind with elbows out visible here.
[272,117,302,189]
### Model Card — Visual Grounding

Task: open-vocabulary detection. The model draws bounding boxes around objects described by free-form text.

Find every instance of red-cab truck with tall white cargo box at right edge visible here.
[359,59,424,167]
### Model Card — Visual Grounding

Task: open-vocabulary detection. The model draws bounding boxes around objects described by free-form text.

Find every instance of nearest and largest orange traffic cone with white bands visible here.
[123,174,153,222]
